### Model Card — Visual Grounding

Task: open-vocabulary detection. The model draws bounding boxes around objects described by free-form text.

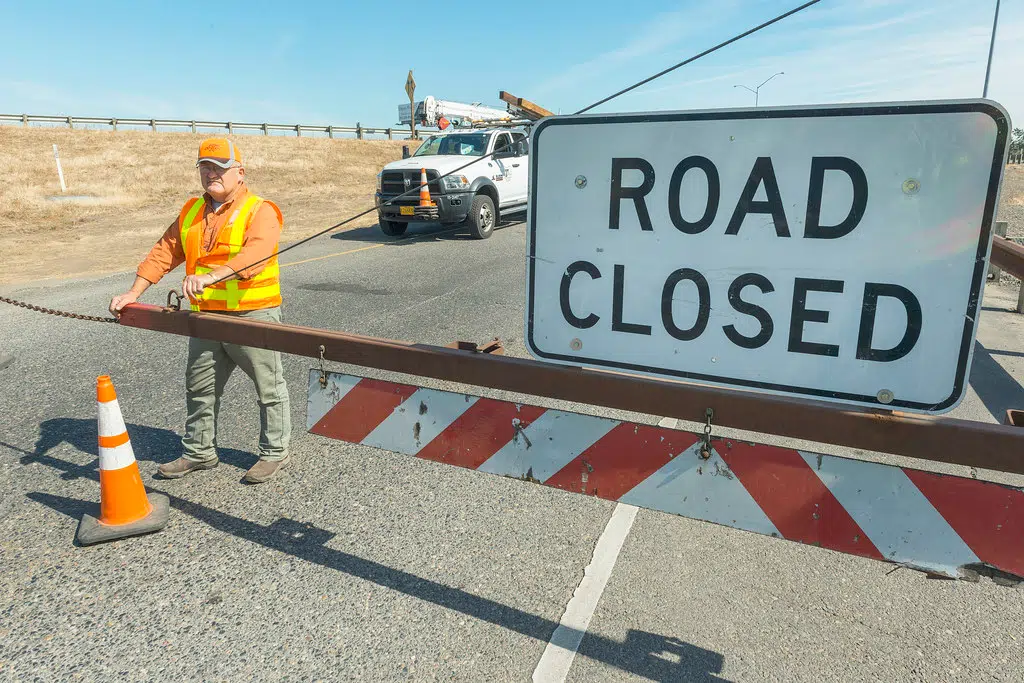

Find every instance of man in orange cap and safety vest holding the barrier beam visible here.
[110,138,291,483]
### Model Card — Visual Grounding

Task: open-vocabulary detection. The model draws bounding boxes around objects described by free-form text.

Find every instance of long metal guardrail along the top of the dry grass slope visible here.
[0,114,428,140]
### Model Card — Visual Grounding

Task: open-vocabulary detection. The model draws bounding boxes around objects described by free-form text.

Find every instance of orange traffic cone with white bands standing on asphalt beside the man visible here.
[76,375,170,546]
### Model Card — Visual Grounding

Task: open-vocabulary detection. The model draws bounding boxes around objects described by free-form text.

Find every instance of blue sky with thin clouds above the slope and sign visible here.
[0,0,1024,127]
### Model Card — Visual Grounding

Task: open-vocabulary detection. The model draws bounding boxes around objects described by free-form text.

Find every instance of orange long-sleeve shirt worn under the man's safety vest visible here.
[135,184,284,285]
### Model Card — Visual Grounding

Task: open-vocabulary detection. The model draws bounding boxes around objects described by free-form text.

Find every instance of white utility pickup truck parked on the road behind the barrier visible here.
[376,128,529,240]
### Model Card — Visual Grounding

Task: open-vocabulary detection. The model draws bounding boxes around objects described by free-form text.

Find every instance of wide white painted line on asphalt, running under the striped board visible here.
[534,418,678,683]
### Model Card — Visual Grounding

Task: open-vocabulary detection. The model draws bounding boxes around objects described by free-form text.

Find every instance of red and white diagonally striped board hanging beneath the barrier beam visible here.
[307,370,1024,578]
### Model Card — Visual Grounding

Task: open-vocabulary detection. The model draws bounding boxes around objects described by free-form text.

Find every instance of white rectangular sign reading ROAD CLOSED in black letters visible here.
[525,100,1010,413]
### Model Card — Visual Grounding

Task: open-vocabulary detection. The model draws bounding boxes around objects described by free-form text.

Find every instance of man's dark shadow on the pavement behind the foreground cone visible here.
[12,418,257,481]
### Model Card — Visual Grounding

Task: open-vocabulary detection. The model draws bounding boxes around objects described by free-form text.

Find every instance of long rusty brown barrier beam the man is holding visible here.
[121,304,1024,474]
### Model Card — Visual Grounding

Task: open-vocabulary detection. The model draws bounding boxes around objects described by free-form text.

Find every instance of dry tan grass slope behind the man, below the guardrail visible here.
[0,126,418,284]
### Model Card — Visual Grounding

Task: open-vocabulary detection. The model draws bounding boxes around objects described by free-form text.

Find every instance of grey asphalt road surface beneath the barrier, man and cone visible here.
[0,223,1024,681]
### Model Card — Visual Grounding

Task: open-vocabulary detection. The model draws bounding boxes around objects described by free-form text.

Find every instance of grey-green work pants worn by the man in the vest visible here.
[181,308,292,462]
